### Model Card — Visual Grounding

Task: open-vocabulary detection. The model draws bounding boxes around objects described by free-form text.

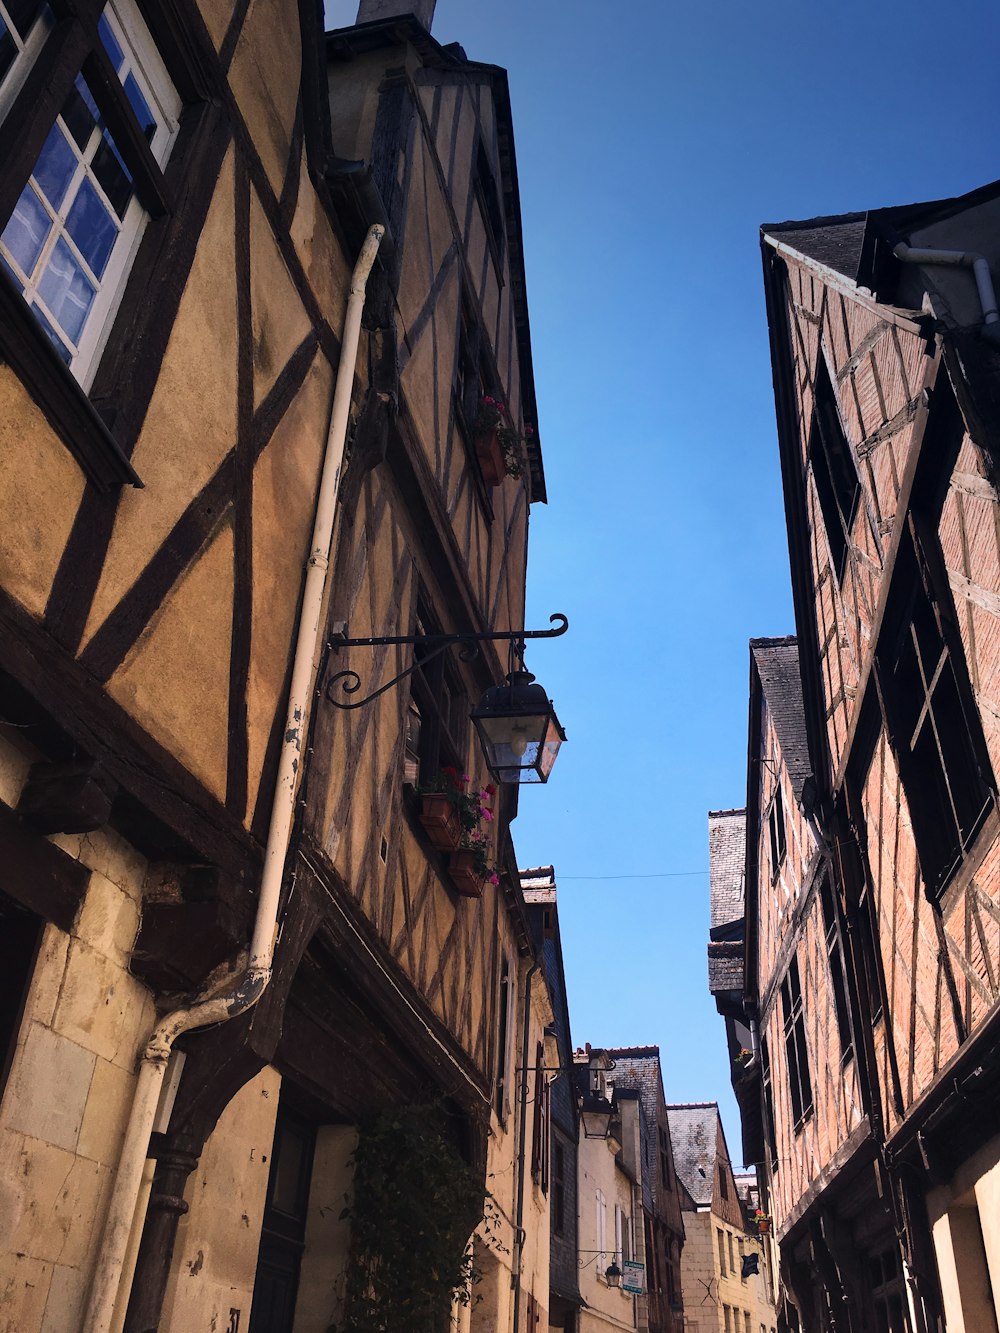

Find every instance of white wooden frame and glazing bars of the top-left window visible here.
[0,0,181,391]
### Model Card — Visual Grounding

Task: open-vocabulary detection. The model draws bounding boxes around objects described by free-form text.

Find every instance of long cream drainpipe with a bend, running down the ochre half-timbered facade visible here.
[84,225,385,1333]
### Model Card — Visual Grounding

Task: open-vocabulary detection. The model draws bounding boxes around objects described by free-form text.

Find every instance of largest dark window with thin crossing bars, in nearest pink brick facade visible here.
[876,517,996,894]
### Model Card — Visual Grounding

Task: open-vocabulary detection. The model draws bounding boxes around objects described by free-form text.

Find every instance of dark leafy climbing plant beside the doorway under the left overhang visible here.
[336,1106,485,1333]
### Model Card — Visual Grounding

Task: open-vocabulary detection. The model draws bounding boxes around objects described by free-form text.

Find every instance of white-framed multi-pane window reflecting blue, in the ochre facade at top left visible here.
[0,0,181,388]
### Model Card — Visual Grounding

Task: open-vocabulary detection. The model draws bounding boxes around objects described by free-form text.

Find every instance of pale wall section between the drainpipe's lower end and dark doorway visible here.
[160,1069,281,1333]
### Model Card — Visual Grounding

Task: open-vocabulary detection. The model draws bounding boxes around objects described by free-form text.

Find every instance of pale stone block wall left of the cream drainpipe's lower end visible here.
[0,737,155,1333]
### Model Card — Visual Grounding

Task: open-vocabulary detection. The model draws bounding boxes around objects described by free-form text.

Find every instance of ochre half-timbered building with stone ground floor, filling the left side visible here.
[0,0,553,1333]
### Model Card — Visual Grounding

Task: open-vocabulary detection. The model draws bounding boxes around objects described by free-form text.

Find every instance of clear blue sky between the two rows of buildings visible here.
[327,0,1000,1162]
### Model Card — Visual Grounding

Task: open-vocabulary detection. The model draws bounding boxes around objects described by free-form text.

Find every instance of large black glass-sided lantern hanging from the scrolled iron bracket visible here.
[472,669,565,784]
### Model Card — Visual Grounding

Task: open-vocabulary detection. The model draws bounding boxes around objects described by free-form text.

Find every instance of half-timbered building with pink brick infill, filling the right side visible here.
[720,185,1000,1333]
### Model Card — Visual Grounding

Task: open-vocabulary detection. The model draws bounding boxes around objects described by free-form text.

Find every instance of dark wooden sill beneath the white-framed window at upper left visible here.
[0,271,143,491]
